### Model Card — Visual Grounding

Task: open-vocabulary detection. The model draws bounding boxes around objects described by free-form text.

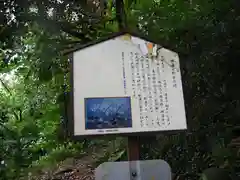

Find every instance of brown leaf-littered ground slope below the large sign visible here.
[31,140,123,180]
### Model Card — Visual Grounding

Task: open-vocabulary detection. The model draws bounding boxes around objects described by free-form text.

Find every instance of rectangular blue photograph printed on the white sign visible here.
[85,97,132,129]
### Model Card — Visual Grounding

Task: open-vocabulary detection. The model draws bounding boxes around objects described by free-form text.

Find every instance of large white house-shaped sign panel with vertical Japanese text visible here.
[73,35,187,136]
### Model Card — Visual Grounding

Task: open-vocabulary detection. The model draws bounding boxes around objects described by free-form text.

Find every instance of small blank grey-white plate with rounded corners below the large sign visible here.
[95,160,172,180]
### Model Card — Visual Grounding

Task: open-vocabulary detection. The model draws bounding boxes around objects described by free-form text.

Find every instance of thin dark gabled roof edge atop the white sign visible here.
[65,30,177,54]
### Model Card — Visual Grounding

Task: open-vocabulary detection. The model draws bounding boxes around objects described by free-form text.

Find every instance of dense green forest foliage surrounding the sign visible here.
[0,0,240,180]
